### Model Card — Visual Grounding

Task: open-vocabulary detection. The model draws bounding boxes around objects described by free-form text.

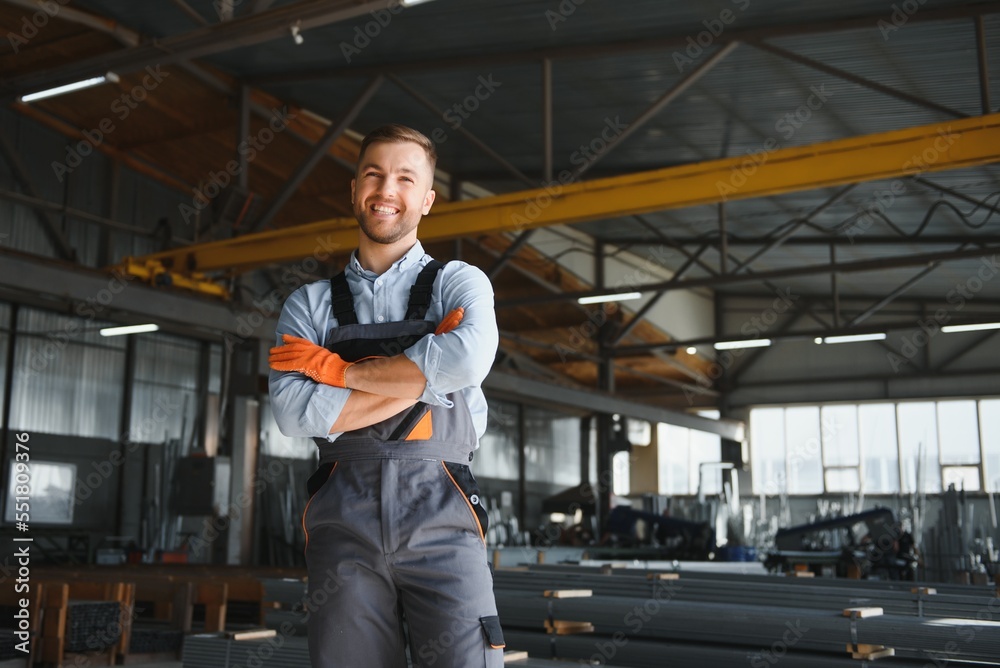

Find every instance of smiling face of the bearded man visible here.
[351,142,434,245]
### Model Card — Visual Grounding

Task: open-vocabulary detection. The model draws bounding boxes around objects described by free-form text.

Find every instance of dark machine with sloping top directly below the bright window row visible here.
[765,508,919,580]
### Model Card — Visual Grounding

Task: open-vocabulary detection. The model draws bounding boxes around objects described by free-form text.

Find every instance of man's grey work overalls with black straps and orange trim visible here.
[302,261,504,668]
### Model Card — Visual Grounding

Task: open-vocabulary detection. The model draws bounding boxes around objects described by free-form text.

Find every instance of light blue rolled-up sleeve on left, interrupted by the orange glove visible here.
[268,286,351,438]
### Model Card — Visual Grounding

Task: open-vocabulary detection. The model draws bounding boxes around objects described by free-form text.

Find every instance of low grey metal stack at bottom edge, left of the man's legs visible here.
[181,633,310,668]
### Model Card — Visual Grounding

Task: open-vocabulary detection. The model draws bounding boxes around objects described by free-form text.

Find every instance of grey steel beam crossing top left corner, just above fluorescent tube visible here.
[0,0,410,102]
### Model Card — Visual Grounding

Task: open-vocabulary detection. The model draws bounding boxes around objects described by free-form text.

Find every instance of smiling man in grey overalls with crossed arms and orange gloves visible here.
[269,125,504,668]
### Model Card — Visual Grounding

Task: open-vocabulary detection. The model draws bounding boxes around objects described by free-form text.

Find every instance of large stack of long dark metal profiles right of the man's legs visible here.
[494,567,1000,666]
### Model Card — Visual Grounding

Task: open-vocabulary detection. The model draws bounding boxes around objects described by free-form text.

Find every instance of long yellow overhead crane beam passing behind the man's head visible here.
[123,114,1000,282]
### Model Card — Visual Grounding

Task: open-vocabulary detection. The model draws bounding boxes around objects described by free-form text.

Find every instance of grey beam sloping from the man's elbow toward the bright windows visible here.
[483,371,744,441]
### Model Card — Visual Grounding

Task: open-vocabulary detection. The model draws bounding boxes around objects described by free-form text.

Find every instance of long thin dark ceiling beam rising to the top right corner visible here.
[240,2,1000,84]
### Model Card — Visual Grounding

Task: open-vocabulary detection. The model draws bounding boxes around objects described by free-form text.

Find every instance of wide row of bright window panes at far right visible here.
[750,399,1000,495]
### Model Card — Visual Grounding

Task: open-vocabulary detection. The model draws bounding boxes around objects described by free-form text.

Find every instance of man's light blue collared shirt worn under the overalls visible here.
[268,241,499,447]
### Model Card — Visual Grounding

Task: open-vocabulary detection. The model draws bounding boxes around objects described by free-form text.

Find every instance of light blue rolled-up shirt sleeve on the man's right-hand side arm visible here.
[405,263,499,408]
